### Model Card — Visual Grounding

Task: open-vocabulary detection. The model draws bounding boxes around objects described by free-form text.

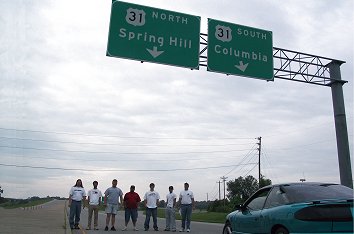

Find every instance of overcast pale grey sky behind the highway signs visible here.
[0,0,354,200]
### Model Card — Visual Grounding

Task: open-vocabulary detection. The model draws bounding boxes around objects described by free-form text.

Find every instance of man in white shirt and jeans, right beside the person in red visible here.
[144,183,160,231]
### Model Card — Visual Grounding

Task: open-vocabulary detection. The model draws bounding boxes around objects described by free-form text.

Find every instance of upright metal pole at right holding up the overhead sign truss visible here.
[327,61,353,188]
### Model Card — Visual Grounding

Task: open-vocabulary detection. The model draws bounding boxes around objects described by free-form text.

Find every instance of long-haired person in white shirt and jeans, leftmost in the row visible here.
[69,179,86,229]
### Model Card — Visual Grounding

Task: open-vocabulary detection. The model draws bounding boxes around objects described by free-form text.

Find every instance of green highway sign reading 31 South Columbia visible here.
[207,19,274,81]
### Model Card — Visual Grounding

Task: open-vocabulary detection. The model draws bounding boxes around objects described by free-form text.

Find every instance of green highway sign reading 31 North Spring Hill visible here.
[107,0,200,69]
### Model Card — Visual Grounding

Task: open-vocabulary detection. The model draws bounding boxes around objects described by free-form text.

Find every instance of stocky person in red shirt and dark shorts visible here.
[122,185,141,231]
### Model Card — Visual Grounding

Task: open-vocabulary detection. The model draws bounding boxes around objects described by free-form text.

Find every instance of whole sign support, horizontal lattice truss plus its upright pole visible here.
[199,33,353,188]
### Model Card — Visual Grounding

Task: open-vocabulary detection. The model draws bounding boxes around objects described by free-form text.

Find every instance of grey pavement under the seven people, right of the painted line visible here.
[73,208,223,234]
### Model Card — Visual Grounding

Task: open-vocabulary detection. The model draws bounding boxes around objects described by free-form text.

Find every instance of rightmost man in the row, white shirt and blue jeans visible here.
[178,183,194,232]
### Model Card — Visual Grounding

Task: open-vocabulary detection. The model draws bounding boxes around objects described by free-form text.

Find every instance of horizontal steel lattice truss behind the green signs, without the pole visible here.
[199,33,347,86]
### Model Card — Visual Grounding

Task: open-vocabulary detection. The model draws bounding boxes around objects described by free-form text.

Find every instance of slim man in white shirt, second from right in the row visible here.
[165,186,177,232]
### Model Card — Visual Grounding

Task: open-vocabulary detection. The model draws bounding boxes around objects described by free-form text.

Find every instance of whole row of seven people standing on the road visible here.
[69,179,195,232]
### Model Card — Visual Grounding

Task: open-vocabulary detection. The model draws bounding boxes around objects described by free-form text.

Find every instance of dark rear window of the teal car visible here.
[281,184,353,203]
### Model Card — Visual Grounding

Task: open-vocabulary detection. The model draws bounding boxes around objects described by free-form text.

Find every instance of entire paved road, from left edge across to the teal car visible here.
[0,200,223,234]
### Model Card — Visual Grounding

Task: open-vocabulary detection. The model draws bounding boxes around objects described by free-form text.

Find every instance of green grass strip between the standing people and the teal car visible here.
[157,209,227,223]
